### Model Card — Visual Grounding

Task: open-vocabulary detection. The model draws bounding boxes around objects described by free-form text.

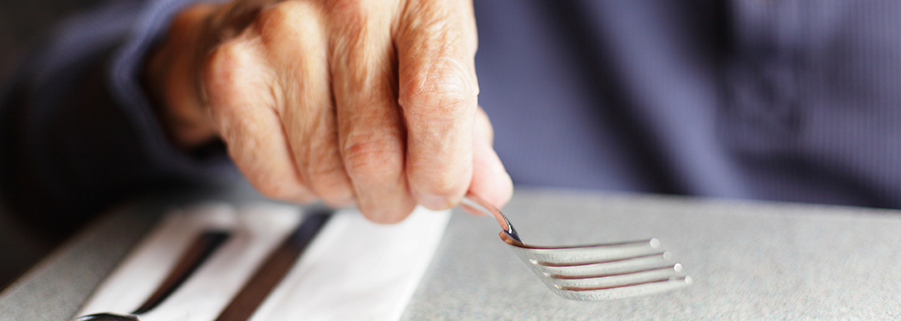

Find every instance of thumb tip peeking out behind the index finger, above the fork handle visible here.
[469,108,513,208]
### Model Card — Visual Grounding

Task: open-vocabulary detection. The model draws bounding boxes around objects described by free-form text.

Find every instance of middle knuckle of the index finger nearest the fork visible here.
[399,59,479,120]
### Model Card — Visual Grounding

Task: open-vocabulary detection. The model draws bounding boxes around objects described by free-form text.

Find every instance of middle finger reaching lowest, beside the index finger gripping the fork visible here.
[329,3,416,223]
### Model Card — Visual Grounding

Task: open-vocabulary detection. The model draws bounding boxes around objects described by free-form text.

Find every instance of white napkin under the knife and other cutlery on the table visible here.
[79,203,450,321]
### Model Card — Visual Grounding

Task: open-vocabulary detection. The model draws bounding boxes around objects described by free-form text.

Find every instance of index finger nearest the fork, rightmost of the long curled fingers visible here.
[397,1,479,209]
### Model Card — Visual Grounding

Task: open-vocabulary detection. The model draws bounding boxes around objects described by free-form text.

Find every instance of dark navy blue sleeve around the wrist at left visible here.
[0,0,236,232]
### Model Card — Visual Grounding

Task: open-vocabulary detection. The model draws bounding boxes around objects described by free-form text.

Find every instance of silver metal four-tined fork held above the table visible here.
[461,193,692,301]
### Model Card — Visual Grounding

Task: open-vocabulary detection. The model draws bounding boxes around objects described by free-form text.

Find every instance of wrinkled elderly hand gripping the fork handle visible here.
[145,0,513,223]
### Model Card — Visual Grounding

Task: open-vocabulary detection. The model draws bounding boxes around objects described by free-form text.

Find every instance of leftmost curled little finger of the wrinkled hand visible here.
[202,33,314,202]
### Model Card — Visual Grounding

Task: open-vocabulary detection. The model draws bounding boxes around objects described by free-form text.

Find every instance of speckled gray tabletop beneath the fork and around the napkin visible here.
[0,187,901,320]
